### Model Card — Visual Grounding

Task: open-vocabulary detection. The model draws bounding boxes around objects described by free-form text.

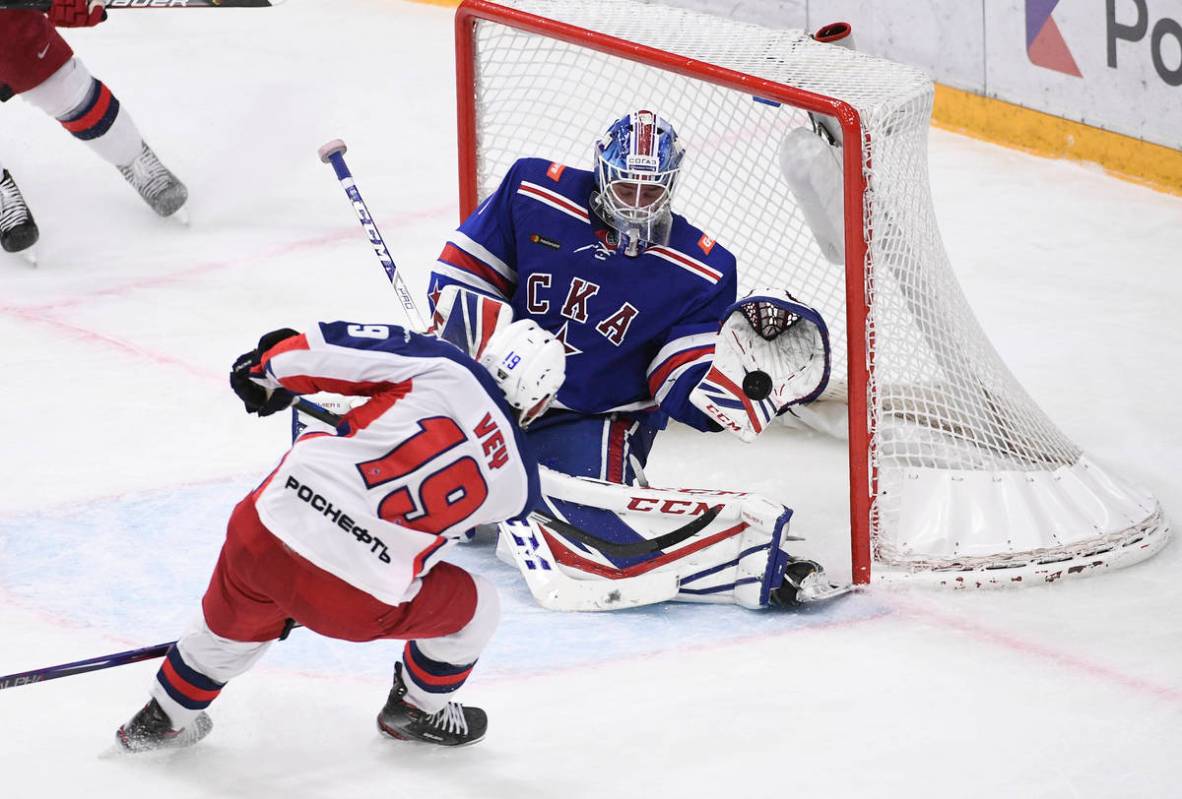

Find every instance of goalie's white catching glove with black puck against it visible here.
[689,288,830,442]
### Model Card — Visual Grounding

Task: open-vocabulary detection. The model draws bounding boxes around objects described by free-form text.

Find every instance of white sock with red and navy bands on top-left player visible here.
[21,58,143,167]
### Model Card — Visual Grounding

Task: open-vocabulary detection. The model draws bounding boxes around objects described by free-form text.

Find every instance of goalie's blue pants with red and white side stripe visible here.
[526,410,667,485]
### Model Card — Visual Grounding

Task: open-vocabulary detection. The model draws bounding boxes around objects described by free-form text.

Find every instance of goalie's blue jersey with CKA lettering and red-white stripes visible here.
[430,158,736,430]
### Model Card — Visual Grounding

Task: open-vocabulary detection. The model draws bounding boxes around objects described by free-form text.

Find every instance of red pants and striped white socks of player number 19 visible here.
[151,496,500,729]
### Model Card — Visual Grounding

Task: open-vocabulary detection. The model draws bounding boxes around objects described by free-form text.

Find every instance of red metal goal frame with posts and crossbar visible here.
[455,0,877,585]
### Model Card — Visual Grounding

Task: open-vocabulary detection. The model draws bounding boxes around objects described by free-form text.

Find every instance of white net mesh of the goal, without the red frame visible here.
[458,0,1164,569]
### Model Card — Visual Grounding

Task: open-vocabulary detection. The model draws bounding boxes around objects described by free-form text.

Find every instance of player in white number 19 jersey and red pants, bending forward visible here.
[116,320,564,752]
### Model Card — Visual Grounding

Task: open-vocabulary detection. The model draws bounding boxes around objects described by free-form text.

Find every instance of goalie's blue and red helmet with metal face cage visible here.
[592,110,686,255]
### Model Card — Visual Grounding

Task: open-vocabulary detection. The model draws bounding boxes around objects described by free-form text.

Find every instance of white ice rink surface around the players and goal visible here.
[0,0,1182,799]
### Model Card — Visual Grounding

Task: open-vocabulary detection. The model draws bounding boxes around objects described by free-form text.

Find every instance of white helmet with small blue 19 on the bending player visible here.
[480,319,566,429]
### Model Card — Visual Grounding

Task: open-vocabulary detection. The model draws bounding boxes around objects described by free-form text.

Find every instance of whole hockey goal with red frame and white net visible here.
[456,0,1169,587]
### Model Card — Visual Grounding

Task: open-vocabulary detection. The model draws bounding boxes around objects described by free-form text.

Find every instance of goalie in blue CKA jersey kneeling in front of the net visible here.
[429,110,829,606]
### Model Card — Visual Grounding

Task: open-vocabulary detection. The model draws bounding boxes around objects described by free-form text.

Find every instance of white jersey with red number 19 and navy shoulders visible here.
[255,321,538,605]
